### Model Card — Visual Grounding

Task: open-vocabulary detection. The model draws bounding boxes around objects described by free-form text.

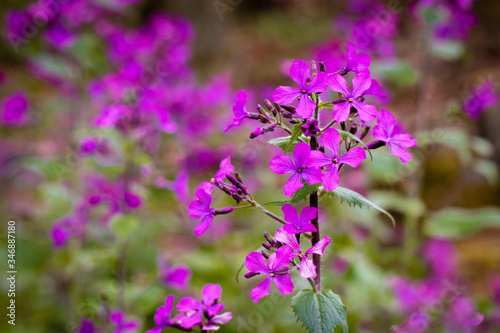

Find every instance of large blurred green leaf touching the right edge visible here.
[424,207,500,238]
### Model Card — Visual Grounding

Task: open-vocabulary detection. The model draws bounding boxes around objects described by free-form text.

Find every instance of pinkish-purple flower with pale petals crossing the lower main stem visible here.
[274,227,332,279]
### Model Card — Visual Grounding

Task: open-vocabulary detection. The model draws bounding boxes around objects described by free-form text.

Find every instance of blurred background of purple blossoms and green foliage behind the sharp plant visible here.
[0,0,500,333]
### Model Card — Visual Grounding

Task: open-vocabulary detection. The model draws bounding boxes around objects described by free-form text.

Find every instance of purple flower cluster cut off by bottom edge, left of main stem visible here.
[147,284,232,333]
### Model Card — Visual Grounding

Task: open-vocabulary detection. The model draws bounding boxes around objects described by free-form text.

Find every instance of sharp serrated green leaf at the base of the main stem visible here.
[292,289,349,333]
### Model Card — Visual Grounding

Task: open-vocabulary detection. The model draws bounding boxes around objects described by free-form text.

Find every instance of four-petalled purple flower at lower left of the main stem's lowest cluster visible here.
[245,245,295,303]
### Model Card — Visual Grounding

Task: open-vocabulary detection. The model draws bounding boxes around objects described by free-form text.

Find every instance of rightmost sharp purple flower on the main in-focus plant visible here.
[373,110,417,163]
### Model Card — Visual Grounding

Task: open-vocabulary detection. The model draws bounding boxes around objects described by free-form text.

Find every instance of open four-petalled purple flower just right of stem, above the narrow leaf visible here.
[309,128,366,191]
